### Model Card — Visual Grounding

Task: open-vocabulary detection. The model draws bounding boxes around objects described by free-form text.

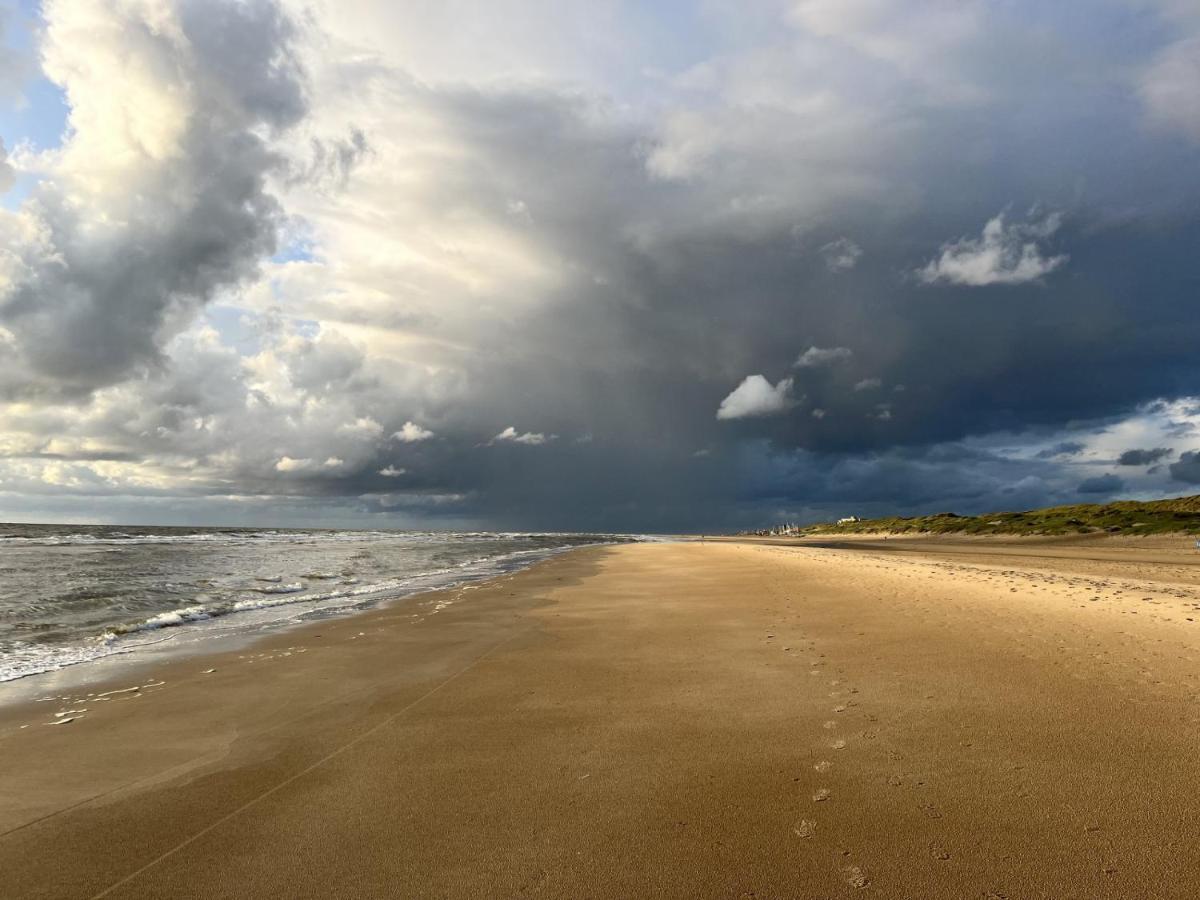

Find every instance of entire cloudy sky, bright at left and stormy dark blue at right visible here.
[0,0,1200,532]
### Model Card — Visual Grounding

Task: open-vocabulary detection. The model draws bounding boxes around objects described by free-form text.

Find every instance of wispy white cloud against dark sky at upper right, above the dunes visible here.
[917,212,1067,287]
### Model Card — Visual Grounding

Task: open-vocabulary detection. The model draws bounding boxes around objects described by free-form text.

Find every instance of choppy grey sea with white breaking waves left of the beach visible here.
[0,524,640,690]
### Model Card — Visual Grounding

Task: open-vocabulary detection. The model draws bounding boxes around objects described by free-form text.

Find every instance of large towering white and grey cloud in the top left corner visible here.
[0,0,306,395]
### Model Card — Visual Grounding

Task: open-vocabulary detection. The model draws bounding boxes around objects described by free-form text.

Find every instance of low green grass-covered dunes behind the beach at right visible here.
[802,496,1200,534]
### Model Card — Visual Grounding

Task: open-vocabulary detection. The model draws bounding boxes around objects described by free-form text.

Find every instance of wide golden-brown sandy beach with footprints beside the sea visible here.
[0,539,1200,900]
